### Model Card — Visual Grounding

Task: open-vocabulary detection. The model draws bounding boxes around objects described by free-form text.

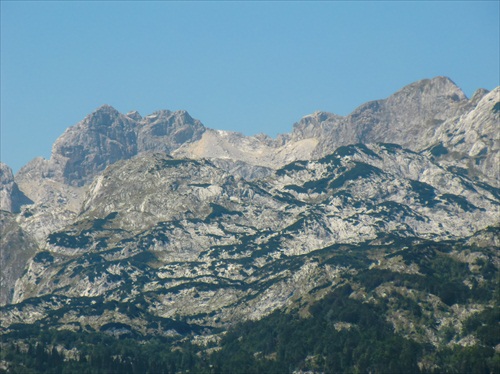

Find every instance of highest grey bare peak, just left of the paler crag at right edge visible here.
[292,77,469,150]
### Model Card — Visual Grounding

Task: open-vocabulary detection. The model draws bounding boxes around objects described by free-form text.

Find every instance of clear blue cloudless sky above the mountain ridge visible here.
[0,0,500,171]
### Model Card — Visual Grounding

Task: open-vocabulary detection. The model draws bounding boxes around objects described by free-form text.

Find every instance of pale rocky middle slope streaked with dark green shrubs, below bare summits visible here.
[3,148,500,329]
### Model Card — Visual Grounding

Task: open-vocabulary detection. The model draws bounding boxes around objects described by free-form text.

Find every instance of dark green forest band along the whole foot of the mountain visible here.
[0,285,500,374]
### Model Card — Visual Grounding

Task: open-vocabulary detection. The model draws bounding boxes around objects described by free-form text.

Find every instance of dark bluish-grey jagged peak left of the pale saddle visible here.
[16,105,204,191]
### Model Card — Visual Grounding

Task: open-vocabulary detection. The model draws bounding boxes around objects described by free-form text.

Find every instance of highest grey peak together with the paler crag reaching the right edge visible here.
[284,77,500,186]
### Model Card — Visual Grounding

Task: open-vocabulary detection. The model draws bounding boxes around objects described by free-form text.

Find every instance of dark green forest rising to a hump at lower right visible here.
[206,285,500,374]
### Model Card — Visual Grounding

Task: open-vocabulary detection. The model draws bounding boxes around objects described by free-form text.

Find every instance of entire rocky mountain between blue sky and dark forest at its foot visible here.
[0,77,500,372]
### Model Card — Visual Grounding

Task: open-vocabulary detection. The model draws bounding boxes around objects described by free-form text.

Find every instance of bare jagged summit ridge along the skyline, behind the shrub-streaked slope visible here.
[9,76,498,202]
